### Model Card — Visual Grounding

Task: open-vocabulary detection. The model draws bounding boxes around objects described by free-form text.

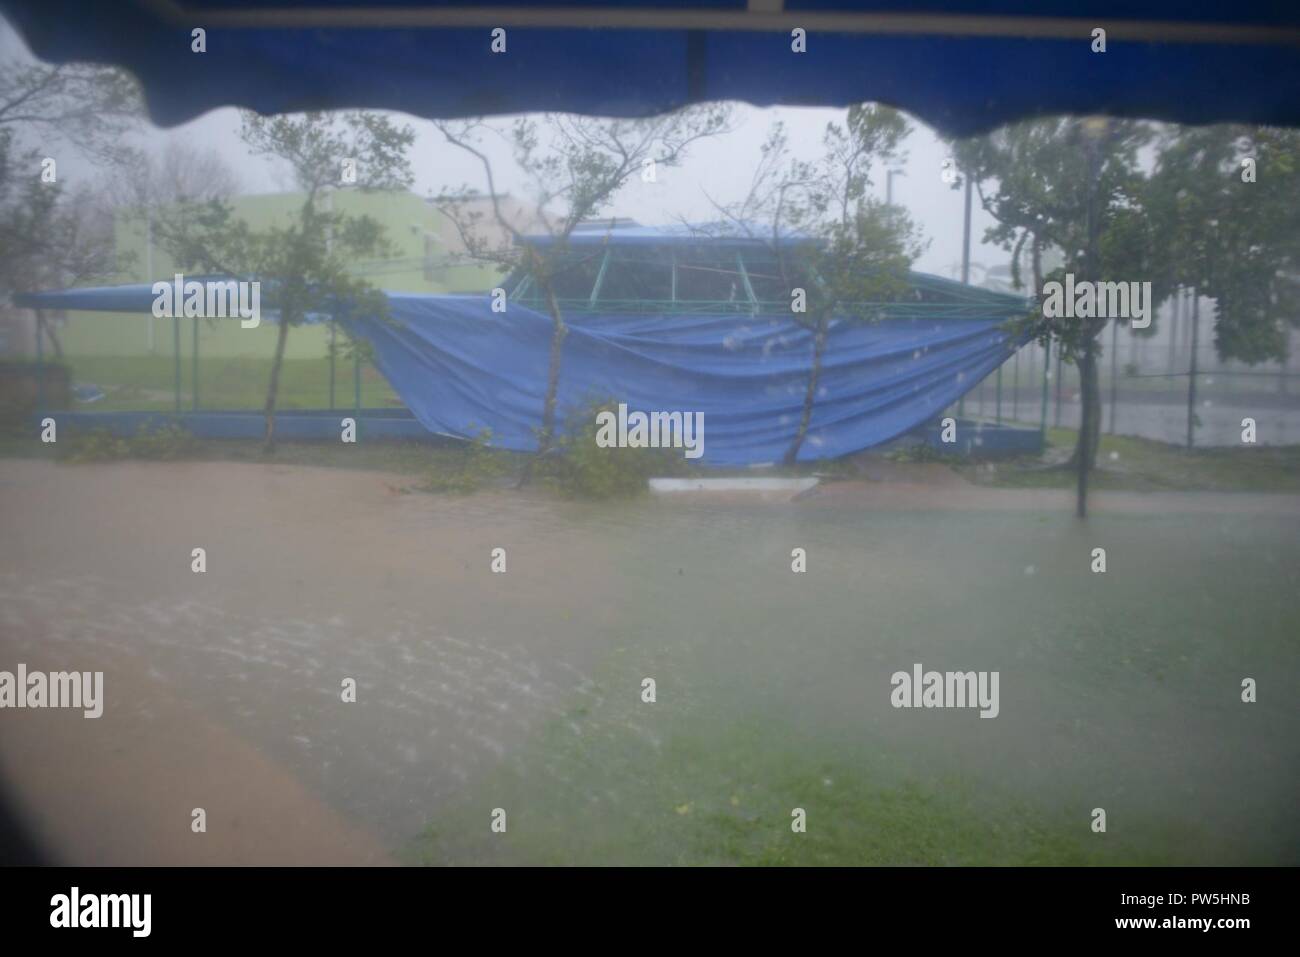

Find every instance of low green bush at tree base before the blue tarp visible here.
[540,399,686,499]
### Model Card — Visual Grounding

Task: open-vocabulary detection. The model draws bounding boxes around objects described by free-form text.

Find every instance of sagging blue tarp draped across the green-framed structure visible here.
[351,294,1024,465]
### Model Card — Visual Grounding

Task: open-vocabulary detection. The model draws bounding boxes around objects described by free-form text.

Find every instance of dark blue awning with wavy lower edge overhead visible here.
[0,0,1300,134]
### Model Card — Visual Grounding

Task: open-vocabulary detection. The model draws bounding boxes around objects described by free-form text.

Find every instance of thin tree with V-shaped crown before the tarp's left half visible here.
[436,105,729,468]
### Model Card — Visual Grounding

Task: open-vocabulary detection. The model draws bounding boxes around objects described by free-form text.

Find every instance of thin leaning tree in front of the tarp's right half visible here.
[714,104,923,464]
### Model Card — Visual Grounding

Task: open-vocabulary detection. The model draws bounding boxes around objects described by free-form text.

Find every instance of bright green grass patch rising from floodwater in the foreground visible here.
[400,735,1102,866]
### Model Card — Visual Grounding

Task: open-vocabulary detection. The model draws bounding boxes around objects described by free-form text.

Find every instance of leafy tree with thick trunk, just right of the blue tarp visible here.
[952,117,1167,518]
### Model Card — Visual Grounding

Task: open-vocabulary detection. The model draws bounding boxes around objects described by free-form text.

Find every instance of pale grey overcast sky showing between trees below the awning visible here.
[0,16,1010,281]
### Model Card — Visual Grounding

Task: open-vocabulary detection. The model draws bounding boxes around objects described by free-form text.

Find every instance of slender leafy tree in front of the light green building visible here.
[156,112,415,451]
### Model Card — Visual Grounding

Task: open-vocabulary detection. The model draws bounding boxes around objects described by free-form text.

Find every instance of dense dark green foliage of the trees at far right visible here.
[952,117,1300,374]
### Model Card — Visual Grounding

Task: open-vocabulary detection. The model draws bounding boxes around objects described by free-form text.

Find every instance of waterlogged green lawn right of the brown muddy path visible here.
[404,505,1300,865]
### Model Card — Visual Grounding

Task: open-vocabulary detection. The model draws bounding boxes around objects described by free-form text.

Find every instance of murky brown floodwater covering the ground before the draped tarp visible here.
[0,460,1300,863]
